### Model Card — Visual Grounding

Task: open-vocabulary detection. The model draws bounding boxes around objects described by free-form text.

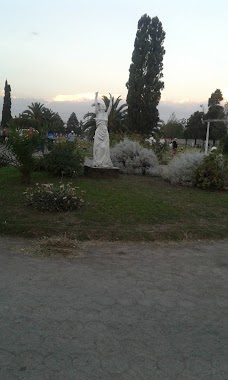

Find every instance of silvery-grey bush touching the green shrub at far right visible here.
[162,152,205,186]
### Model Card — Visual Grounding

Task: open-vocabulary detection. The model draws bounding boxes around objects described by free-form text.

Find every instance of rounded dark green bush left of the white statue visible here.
[45,142,84,177]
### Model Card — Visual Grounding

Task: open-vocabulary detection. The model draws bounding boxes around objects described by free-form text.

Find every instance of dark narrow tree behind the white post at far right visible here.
[206,89,226,144]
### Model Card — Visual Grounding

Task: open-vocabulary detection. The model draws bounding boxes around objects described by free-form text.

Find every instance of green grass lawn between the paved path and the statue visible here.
[0,168,228,241]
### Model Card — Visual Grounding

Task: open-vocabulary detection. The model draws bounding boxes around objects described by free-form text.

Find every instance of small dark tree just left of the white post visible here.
[184,111,206,145]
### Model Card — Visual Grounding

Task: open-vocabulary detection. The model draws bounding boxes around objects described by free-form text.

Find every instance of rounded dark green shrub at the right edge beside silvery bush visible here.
[193,153,228,190]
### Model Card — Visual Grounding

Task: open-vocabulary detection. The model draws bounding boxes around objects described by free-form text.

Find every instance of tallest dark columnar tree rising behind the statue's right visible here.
[126,14,165,135]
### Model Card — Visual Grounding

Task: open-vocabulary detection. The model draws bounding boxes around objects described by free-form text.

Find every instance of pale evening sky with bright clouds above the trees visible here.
[0,0,228,121]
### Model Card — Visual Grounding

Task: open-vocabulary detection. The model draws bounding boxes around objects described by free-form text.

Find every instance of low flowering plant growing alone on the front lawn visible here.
[24,183,84,212]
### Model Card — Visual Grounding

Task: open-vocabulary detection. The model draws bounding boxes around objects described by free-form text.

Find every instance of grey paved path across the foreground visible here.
[0,238,228,380]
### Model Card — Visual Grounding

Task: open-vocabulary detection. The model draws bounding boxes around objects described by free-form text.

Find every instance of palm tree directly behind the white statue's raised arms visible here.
[83,96,127,140]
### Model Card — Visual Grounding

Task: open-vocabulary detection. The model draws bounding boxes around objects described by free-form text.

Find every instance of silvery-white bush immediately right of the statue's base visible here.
[111,139,159,175]
